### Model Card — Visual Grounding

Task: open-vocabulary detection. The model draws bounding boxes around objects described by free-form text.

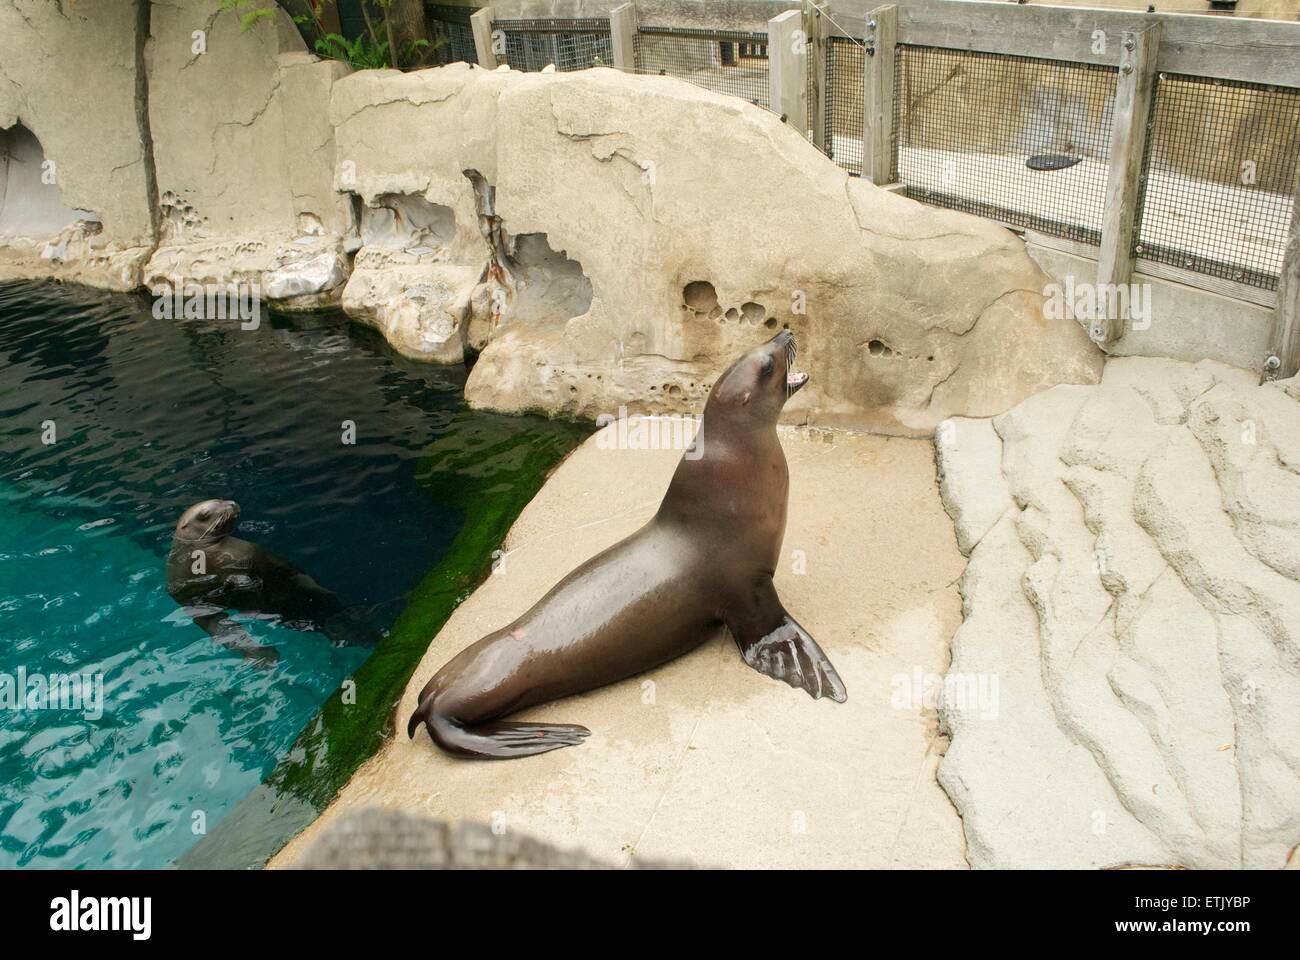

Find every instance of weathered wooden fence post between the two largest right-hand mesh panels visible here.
[1088,22,1160,346]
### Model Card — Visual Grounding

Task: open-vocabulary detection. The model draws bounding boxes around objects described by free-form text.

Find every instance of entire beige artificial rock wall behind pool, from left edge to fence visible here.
[0,0,1102,434]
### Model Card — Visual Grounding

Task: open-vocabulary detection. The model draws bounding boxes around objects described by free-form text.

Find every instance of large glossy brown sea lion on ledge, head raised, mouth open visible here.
[407,330,845,758]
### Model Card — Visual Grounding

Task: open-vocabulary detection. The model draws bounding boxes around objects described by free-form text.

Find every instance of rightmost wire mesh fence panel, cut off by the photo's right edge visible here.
[1134,74,1300,290]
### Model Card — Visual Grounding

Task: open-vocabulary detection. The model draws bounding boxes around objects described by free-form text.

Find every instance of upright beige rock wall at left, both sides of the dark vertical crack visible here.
[0,0,354,307]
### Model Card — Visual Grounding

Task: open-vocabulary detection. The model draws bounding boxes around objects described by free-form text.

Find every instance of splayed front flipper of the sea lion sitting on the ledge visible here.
[727,581,849,704]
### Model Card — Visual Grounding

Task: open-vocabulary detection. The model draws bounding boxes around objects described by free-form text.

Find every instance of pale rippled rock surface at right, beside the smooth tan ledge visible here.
[936,358,1300,868]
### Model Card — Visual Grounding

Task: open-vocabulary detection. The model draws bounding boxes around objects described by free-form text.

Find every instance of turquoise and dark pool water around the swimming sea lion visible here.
[0,282,579,868]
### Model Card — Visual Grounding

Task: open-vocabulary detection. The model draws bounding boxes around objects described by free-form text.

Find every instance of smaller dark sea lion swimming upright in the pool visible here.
[166,500,377,666]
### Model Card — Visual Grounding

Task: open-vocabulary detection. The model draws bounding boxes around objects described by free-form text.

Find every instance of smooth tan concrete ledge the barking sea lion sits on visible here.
[270,428,966,868]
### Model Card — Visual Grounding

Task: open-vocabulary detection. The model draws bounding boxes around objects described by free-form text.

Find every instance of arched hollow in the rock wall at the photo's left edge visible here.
[0,124,99,241]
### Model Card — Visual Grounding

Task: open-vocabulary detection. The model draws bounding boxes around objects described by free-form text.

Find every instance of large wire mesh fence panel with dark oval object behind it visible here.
[893,44,1117,245]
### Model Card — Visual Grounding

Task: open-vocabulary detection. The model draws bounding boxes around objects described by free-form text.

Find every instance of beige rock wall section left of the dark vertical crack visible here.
[0,0,152,289]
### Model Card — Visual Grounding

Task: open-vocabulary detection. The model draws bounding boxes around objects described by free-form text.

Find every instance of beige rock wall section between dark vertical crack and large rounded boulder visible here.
[144,0,354,307]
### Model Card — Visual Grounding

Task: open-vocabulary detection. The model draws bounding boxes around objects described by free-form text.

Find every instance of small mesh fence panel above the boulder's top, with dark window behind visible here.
[636,26,770,107]
